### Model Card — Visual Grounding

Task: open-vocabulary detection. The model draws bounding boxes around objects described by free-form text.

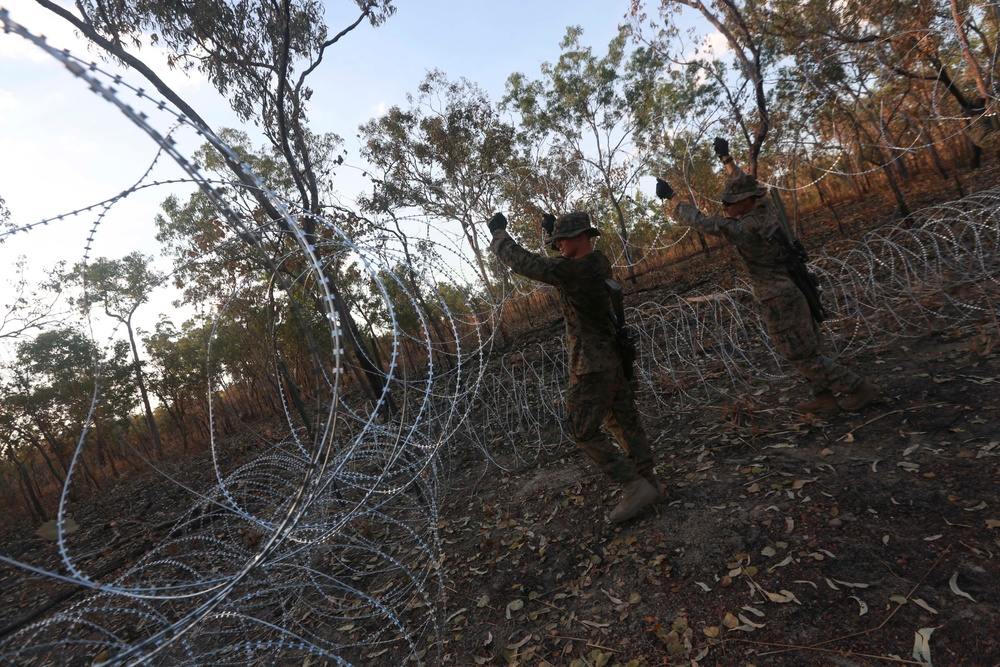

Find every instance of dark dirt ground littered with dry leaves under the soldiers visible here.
[0,160,1000,667]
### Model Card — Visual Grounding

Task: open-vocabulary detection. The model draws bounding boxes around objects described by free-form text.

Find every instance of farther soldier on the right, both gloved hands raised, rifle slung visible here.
[656,139,880,416]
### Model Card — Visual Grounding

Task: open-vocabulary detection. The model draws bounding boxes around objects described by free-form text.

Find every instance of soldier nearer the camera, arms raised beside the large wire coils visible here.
[488,213,664,523]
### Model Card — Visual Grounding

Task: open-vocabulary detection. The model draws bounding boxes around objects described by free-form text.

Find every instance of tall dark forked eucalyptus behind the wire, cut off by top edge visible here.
[36,0,395,412]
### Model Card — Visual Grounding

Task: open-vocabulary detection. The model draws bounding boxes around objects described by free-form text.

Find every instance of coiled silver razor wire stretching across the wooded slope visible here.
[0,10,1000,665]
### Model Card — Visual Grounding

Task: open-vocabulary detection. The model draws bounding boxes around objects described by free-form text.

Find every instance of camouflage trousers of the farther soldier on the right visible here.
[760,289,861,395]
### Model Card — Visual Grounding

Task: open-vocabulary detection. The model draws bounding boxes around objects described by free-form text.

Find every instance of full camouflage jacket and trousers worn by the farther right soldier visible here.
[674,168,862,396]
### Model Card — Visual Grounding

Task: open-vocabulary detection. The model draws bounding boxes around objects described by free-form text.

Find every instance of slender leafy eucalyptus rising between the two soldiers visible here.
[503,27,661,279]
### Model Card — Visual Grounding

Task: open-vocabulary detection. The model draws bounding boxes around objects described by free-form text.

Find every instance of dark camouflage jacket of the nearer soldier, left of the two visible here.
[490,229,622,375]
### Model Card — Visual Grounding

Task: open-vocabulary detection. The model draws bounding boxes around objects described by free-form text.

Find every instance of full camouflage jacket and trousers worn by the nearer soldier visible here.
[490,227,655,486]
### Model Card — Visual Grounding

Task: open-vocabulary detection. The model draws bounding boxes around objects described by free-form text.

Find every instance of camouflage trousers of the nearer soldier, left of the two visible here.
[566,368,653,483]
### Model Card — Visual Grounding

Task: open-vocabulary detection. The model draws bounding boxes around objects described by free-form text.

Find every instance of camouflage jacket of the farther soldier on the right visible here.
[674,193,798,299]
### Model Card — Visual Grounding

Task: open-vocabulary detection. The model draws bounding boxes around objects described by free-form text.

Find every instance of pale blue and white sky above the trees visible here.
[0,0,688,350]
